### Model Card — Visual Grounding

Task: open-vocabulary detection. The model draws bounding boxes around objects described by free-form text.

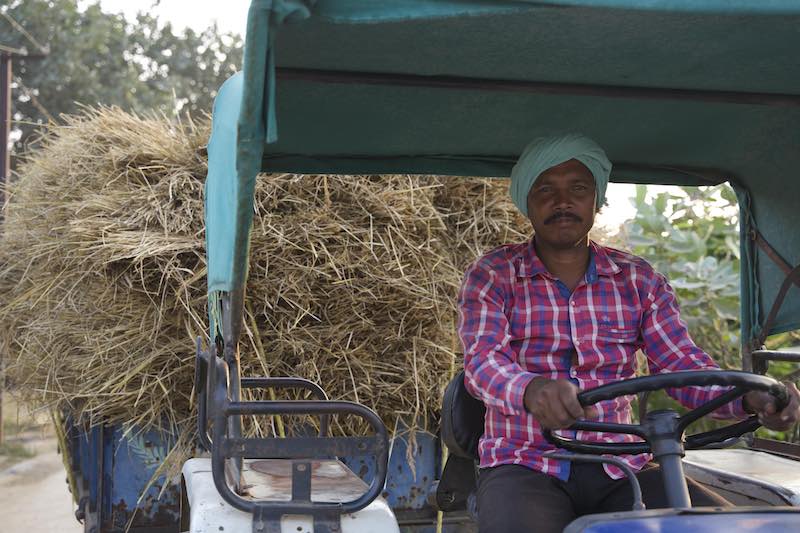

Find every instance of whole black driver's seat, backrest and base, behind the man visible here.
[435,370,486,515]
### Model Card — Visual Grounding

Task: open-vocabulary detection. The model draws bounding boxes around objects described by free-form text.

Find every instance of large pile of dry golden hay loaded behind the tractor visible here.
[0,109,526,466]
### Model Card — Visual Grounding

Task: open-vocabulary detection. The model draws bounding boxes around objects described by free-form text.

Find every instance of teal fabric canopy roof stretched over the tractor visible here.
[207,0,800,348]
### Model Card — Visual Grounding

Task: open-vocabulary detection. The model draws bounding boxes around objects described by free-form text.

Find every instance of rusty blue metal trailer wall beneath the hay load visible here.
[66,419,461,533]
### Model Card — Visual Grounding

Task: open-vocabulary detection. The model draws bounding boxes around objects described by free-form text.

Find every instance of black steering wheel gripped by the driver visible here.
[543,370,789,460]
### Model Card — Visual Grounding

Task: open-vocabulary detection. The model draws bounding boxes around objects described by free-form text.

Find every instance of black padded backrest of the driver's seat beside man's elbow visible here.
[442,370,486,460]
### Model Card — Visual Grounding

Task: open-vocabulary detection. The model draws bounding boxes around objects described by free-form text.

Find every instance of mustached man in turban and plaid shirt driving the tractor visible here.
[459,135,800,533]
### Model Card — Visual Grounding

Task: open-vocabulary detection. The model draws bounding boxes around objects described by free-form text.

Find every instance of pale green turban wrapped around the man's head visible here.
[509,133,611,217]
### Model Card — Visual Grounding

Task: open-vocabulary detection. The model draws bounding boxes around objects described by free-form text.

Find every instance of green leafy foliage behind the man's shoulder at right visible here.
[616,185,800,442]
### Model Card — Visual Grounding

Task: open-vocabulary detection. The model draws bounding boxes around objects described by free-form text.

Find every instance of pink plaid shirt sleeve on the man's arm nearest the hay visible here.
[458,260,537,416]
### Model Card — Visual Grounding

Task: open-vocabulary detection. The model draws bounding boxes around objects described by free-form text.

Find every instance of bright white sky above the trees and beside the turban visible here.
[95,0,635,227]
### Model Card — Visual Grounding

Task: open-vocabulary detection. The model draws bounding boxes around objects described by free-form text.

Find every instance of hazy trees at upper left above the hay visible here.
[0,0,242,157]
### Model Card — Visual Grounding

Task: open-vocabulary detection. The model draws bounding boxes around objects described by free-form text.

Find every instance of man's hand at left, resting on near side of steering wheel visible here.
[525,378,597,429]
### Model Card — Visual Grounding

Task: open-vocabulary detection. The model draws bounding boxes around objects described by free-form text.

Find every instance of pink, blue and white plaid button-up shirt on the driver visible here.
[458,240,746,480]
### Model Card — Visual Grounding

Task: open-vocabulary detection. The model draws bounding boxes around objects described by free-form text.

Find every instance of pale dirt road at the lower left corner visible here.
[0,439,83,533]
